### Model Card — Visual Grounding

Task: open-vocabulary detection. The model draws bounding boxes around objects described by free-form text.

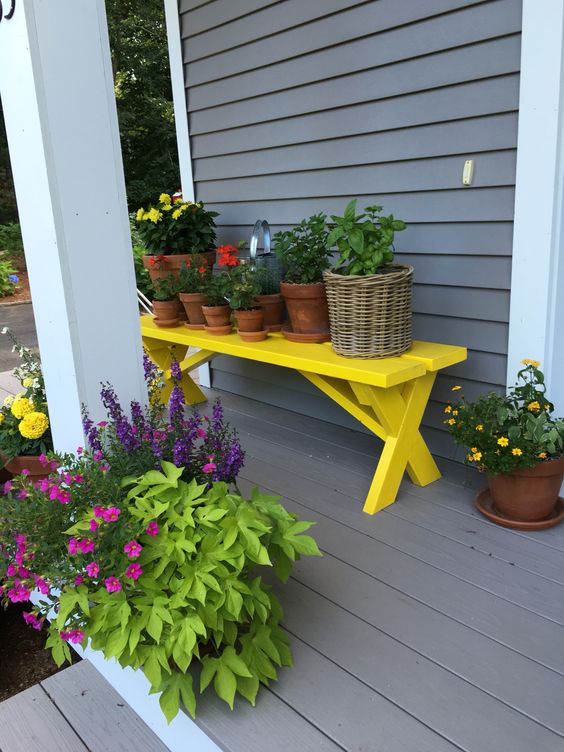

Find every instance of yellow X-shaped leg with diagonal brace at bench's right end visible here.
[302,372,441,514]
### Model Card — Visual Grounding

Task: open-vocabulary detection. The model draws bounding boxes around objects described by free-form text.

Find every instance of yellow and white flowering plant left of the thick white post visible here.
[0,328,53,462]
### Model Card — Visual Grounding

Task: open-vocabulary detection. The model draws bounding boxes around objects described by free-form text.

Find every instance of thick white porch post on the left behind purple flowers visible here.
[0,0,146,451]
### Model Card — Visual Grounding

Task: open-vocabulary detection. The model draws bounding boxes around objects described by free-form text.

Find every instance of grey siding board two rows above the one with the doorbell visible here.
[188,74,519,159]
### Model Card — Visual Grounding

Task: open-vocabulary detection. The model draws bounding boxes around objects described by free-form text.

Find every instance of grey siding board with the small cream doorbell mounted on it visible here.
[198,150,515,203]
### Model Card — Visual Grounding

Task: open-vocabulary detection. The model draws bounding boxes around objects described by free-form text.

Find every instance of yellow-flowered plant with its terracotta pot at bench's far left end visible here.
[135,193,218,280]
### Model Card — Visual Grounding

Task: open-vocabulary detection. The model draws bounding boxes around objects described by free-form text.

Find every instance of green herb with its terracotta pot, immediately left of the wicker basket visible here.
[274,214,330,336]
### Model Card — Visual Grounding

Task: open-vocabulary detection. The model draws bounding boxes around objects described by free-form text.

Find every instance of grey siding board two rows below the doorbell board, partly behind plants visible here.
[218,223,513,256]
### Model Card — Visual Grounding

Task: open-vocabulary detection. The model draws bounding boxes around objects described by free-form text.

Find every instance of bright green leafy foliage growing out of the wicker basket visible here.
[327,199,405,275]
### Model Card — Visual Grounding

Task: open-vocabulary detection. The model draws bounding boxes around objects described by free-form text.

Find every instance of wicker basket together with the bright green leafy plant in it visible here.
[324,199,413,358]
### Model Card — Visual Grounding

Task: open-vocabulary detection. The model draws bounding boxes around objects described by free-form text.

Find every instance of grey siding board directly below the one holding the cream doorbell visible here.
[205,187,514,227]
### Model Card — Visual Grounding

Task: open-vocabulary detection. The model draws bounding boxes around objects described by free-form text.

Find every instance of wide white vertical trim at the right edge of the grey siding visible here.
[507,0,564,413]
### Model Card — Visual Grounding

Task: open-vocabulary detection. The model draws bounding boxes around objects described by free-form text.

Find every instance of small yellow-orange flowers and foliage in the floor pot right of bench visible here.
[444,358,564,475]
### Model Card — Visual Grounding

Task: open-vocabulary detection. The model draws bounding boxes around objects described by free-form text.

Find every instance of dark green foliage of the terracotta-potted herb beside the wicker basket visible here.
[274,214,331,285]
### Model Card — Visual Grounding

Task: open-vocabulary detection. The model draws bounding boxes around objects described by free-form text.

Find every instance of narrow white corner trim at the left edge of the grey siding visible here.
[164,0,211,387]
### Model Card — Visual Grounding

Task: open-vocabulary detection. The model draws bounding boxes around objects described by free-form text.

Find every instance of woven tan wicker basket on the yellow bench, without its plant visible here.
[324,265,413,358]
